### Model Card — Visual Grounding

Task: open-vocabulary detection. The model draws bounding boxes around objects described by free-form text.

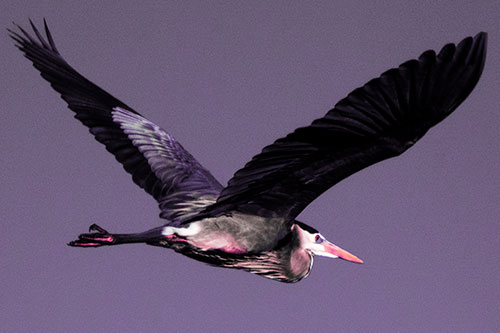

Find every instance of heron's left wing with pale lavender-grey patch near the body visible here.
[9,21,222,224]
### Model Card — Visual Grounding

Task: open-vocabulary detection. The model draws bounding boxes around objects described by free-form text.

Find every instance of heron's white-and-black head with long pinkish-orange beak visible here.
[293,221,363,264]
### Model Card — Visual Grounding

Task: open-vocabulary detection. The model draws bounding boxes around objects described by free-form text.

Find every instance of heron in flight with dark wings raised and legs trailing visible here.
[7,19,487,283]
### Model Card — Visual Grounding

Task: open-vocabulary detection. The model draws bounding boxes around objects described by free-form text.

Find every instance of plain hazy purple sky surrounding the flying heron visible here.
[0,0,500,332]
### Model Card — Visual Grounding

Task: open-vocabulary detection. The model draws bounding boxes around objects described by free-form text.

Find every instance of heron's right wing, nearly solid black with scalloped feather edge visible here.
[202,32,487,221]
